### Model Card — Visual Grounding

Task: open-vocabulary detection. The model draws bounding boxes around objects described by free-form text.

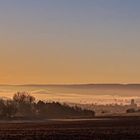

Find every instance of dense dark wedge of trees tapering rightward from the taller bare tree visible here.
[36,101,95,118]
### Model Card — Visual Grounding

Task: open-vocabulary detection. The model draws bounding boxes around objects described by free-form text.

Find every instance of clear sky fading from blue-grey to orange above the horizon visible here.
[0,0,140,84]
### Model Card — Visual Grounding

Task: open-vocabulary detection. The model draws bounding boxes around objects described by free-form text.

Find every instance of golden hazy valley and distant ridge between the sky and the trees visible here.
[0,84,140,104]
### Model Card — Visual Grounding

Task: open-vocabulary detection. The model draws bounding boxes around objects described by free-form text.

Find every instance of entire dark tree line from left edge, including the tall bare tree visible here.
[0,92,95,119]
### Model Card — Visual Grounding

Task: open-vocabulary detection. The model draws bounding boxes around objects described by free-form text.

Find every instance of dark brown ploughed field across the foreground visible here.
[0,117,140,140]
